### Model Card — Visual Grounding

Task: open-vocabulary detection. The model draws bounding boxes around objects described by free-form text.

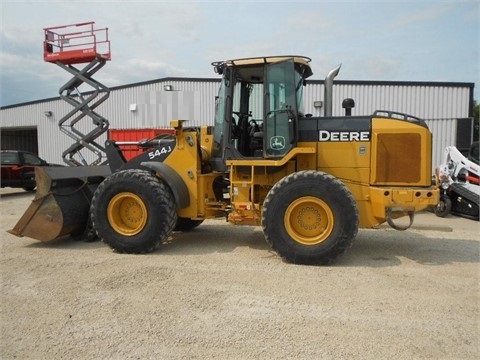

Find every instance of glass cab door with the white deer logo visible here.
[263,59,302,157]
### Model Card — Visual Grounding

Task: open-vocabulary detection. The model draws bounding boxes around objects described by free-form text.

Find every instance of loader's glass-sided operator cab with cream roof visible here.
[212,56,312,171]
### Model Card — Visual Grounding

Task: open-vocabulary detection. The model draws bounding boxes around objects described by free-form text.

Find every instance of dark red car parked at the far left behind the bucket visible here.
[0,150,62,191]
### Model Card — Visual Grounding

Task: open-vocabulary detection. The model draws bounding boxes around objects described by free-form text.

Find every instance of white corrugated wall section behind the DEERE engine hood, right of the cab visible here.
[305,81,473,171]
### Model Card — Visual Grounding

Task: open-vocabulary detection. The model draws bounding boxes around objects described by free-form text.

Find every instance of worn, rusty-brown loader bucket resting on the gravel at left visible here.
[8,165,111,242]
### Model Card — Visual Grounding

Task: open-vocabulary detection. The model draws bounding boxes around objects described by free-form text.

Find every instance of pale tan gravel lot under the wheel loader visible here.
[0,189,480,359]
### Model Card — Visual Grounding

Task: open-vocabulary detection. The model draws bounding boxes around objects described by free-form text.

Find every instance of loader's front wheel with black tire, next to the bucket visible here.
[90,169,177,254]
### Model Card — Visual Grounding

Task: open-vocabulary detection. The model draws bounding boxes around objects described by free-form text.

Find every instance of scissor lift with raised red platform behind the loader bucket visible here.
[43,22,111,166]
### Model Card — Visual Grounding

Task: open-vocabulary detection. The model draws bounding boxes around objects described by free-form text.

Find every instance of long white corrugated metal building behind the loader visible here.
[0,78,474,173]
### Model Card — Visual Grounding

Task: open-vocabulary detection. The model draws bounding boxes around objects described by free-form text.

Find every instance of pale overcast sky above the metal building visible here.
[0,0,480,106]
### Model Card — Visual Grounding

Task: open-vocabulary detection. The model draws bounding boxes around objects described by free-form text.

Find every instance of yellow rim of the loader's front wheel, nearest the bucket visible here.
[107,192,147,236]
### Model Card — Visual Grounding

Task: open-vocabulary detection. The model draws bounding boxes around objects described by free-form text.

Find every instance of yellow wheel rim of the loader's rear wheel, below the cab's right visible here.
[284,196,335,245]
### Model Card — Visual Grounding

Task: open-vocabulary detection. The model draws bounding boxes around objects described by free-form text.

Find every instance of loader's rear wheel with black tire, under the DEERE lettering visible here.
[262,171,358,265]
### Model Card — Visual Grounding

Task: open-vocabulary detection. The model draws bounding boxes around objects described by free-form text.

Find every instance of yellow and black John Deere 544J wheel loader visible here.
[10,39,439,264]
